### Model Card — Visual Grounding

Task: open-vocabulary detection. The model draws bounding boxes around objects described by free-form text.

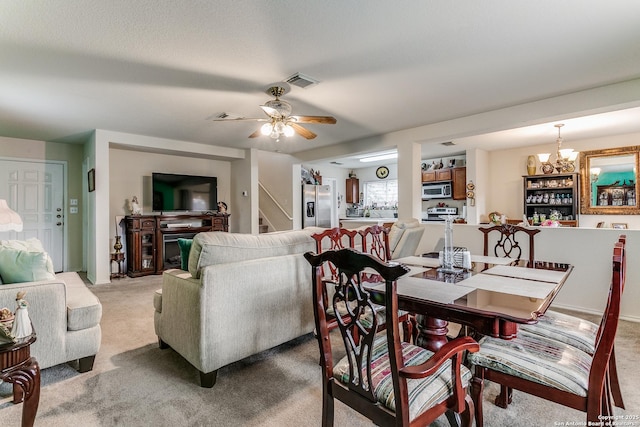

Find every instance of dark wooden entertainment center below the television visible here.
[124,213,229,277]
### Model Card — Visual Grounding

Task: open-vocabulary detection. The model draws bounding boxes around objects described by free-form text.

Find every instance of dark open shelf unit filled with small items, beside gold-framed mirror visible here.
[523,173,580,227]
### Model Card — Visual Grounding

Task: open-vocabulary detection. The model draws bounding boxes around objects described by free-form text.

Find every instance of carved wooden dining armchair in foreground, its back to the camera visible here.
[304,249,482,426]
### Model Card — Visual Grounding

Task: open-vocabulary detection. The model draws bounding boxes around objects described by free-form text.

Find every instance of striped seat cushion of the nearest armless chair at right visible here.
[467,329,592,397]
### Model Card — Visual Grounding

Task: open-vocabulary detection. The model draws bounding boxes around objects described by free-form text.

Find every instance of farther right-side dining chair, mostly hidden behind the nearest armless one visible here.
[520,234,627,409]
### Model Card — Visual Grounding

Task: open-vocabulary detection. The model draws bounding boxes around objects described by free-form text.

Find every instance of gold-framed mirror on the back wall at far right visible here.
[580,146,640,215]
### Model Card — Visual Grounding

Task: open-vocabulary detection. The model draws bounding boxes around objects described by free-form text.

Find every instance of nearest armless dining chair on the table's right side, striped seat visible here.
[467,236,626,427]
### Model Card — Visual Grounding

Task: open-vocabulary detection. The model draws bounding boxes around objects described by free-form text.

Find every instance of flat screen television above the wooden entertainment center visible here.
[151,172,218,212]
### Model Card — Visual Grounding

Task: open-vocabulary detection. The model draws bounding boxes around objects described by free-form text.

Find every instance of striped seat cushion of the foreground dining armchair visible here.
[333,334,471,419]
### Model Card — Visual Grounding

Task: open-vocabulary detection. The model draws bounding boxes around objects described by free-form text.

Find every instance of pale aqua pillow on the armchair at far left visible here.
[0,246,55,283]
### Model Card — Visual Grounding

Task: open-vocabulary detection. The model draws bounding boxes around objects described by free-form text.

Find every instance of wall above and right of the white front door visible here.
[0,136,86,271]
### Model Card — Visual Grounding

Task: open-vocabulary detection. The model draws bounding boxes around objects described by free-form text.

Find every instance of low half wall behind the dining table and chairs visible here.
[417,224,640,322]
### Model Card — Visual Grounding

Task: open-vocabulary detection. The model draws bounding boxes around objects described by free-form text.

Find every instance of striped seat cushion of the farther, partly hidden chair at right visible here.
[520,310,598,355]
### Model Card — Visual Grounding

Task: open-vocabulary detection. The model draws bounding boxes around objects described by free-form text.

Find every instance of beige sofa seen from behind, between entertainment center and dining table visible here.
[154,228,319,387]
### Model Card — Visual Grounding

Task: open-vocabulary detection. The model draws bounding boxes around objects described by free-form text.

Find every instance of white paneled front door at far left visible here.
[0,159,64,272]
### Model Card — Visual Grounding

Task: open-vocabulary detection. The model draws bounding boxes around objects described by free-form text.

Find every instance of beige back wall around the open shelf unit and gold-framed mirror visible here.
[484,133,640,229]
